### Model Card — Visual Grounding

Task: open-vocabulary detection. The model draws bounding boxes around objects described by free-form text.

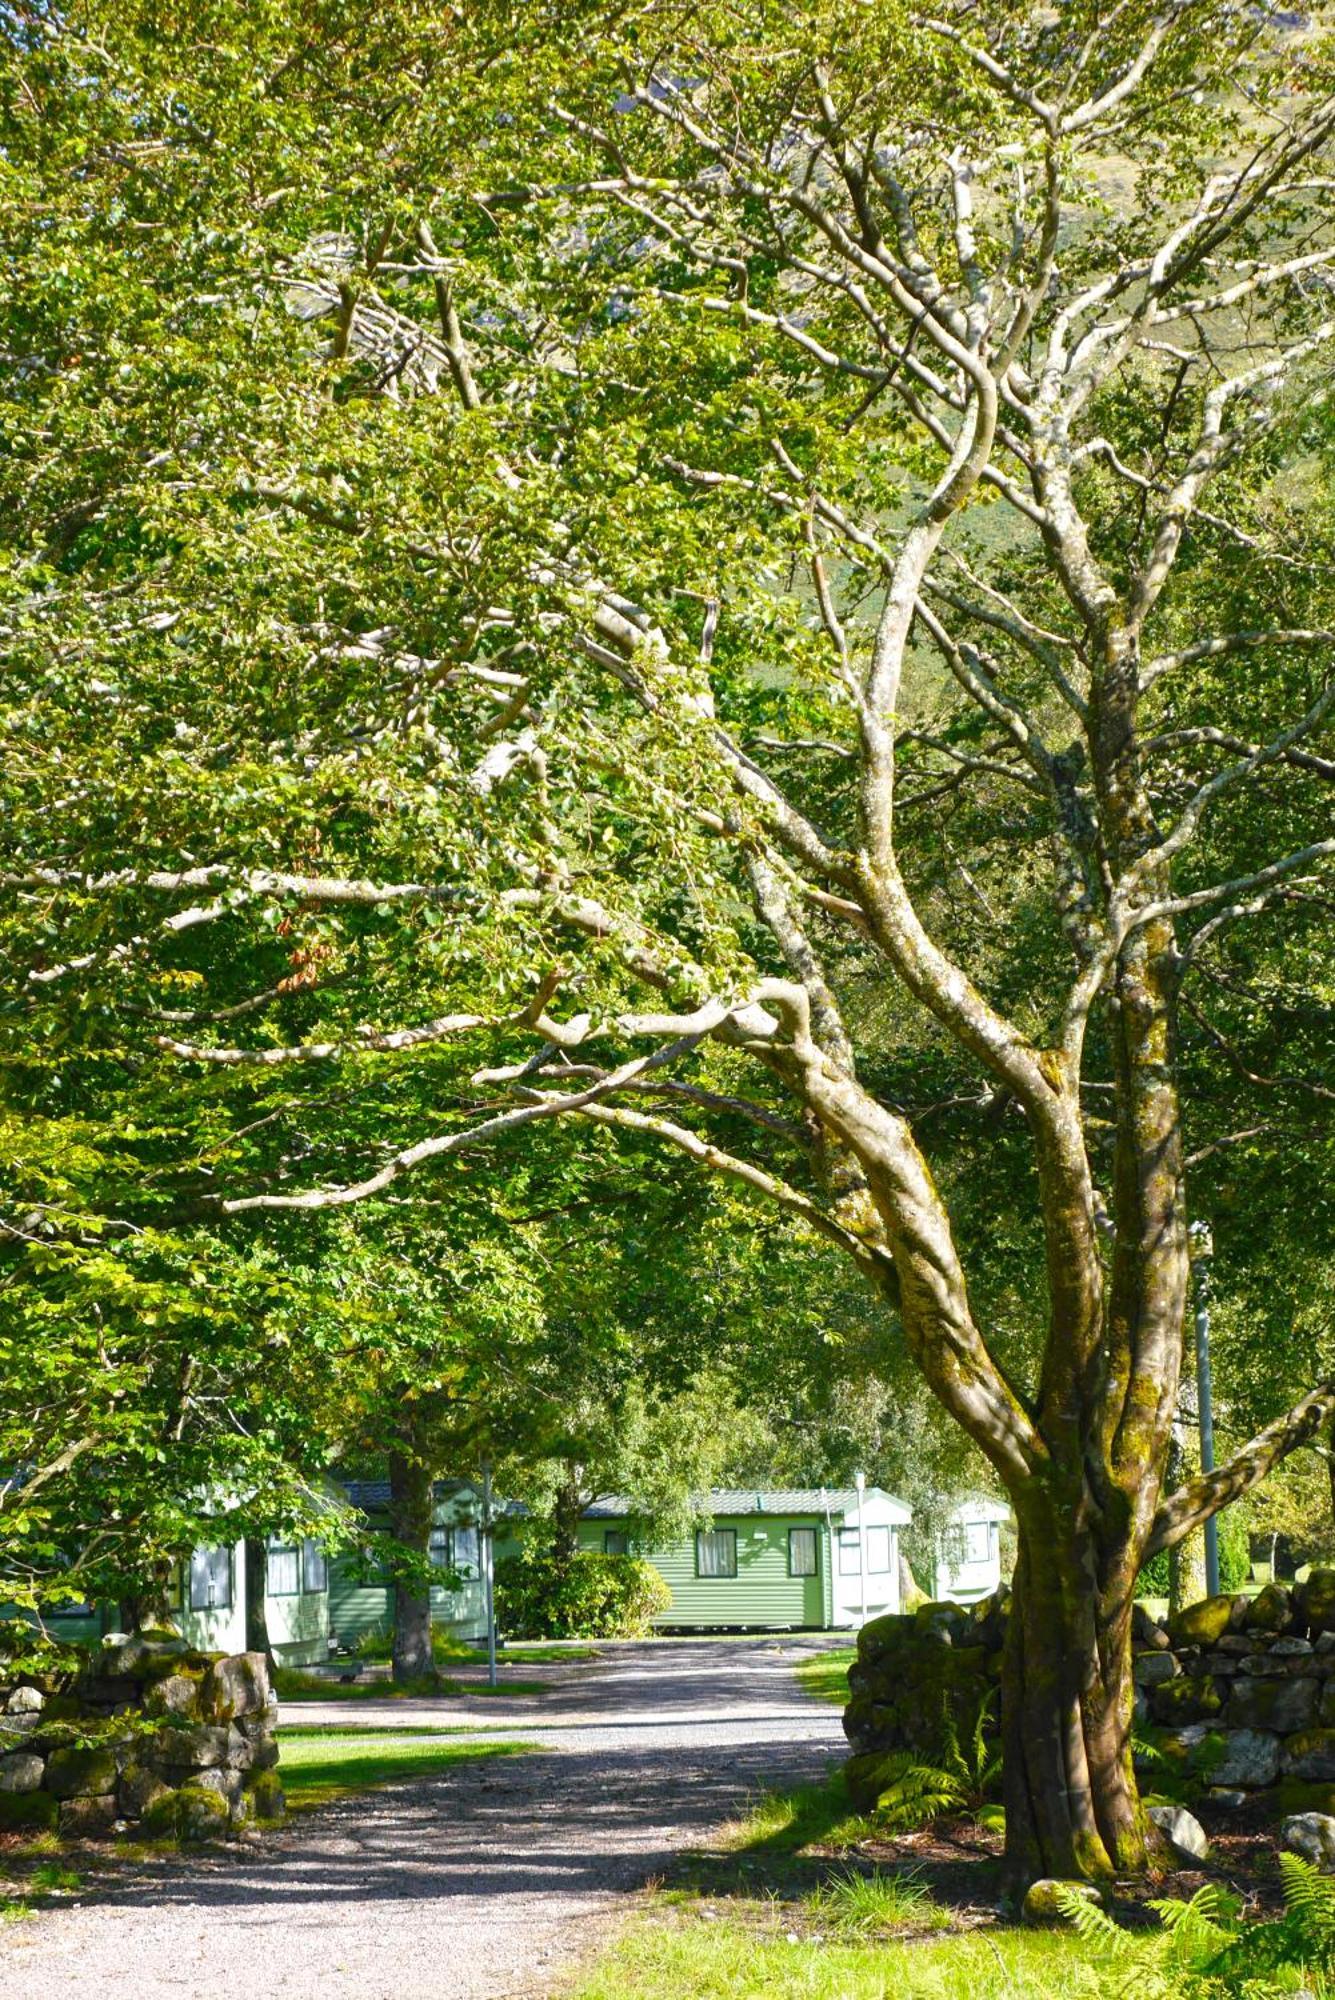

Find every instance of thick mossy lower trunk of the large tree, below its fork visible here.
[1001,1506,1145,1886]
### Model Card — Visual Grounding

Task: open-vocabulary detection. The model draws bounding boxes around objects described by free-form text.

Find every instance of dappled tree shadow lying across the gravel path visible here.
[67,1642,837,1924]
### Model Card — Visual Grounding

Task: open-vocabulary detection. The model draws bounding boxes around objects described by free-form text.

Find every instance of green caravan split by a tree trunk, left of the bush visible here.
[330,1480,508,1652]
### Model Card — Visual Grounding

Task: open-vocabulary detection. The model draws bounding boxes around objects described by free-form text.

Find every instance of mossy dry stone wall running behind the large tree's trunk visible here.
[843,1570,1335,1812]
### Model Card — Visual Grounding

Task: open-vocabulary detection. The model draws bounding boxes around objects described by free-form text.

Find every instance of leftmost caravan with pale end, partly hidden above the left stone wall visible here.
[42,1540,330,1666]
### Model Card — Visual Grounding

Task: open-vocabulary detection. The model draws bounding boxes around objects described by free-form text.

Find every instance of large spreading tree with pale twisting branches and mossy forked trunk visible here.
[4,0,1335,1876]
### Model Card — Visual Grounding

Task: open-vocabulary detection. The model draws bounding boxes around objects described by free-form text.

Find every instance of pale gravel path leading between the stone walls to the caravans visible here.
[0,1640,843,2000]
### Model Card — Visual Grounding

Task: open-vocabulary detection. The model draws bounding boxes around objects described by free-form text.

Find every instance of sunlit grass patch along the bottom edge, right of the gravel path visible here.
[566,1906,1107,2000]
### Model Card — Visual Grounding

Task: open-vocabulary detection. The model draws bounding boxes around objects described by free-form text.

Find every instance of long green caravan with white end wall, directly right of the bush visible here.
[580,1486,913,1632]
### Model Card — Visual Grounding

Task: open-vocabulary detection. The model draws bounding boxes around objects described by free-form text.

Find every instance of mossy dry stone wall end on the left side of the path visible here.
[0,1630,284,1840]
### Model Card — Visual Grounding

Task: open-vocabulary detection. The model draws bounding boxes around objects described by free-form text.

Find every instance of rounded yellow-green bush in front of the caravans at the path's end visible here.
[496,1548,671,1638]
